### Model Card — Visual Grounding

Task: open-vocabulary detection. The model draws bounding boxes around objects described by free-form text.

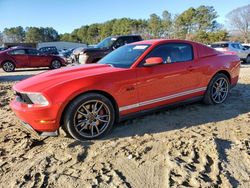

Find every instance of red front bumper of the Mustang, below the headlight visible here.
[10,99,60,135]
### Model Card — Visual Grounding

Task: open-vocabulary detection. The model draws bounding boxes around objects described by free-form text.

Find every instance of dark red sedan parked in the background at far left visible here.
[0,47,66,72]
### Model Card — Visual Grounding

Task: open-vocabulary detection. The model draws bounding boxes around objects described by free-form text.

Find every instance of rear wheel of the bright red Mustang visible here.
[203,73,230,104]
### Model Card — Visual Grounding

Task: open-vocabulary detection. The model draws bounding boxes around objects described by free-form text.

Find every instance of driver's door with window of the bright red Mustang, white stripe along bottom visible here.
[137,43,204,110]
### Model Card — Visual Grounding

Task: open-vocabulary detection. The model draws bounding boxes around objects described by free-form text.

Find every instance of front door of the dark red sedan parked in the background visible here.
[26,49,49,67]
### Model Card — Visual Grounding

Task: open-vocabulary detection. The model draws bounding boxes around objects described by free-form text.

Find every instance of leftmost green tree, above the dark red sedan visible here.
[3,26,25,42]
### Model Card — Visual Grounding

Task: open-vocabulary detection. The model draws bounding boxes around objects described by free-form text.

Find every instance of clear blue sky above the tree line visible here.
[0,0,250,34]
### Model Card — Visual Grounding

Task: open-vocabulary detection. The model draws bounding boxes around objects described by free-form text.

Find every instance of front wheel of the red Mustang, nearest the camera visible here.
[63,93,115,141]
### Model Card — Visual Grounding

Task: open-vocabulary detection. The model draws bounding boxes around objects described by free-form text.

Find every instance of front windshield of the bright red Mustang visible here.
[99,44,150,68]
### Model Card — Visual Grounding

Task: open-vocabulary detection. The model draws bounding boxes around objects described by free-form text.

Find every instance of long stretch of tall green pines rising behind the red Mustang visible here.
[60,5,228,44]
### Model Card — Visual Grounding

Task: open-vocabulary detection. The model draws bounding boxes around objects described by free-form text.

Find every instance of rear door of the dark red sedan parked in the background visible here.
[8,49,29,67]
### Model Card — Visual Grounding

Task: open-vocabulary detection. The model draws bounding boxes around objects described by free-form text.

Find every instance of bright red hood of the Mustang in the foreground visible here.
[13,64,120,92]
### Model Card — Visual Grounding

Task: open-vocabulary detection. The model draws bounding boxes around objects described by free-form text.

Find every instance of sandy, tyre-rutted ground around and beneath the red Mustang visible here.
[0,67,250,188]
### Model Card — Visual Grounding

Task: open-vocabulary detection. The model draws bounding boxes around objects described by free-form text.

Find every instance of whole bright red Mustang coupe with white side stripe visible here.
[11,40,240,140]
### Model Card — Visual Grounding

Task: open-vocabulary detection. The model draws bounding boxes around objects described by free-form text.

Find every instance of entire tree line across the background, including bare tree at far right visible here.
[0,5,250,44]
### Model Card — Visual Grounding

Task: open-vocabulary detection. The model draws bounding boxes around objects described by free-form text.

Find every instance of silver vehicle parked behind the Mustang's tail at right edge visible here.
[211,42,250,63]
